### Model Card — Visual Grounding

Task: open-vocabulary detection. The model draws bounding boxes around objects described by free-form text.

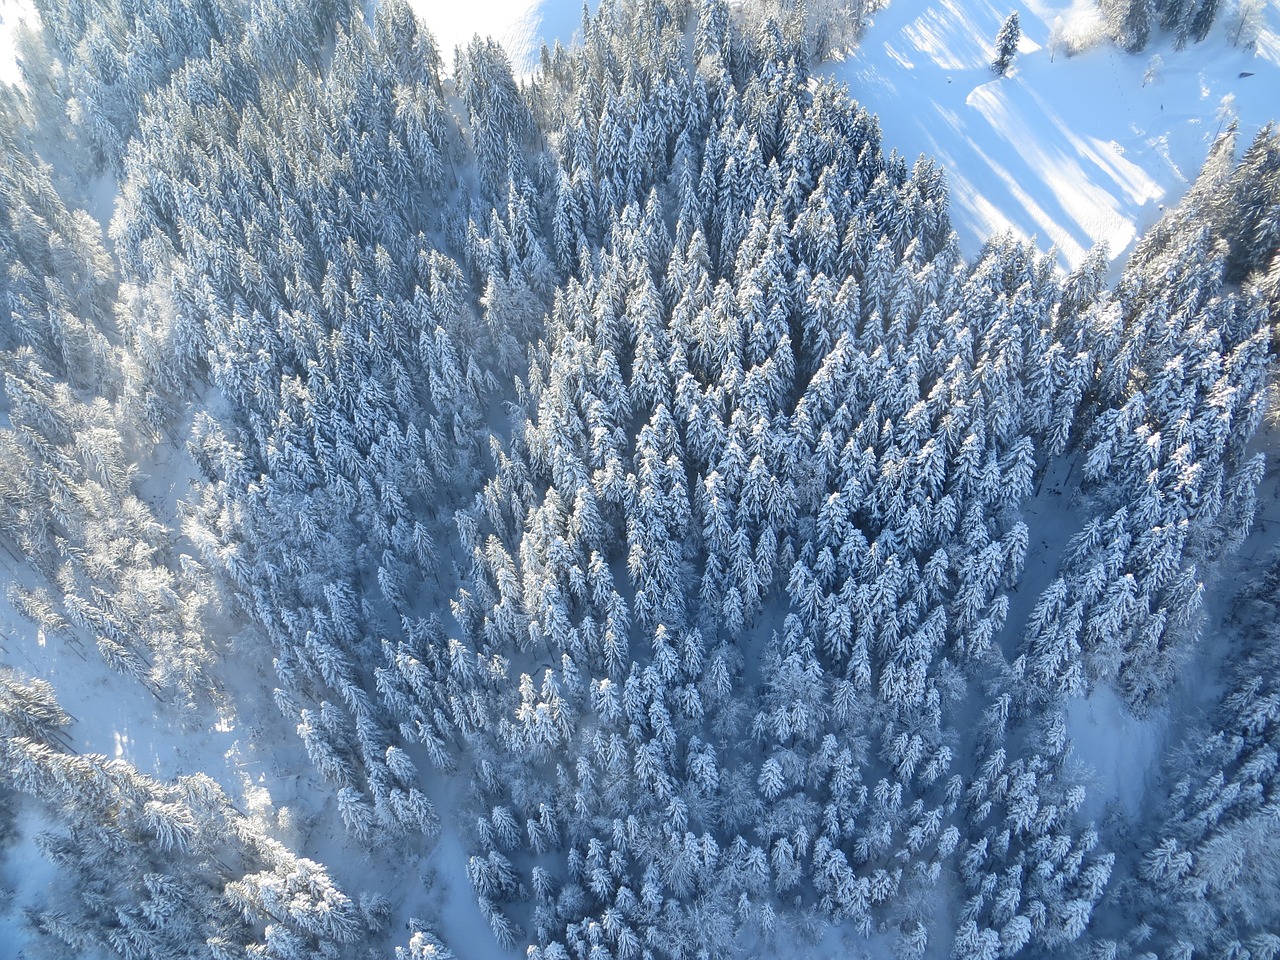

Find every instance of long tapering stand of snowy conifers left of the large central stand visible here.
[113,4,499,835]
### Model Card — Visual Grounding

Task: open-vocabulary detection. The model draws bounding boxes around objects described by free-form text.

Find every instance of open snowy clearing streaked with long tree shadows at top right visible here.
[826,0,1280,266]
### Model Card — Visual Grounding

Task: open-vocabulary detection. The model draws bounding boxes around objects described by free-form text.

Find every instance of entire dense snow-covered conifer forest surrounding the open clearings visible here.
[0,0,1280,960]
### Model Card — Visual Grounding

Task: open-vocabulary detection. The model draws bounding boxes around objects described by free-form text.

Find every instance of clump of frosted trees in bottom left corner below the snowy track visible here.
[0,682,361,960]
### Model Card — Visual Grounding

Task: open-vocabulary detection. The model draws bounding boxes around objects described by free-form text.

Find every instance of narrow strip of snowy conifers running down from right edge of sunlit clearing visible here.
[1024,128,1280,707]
